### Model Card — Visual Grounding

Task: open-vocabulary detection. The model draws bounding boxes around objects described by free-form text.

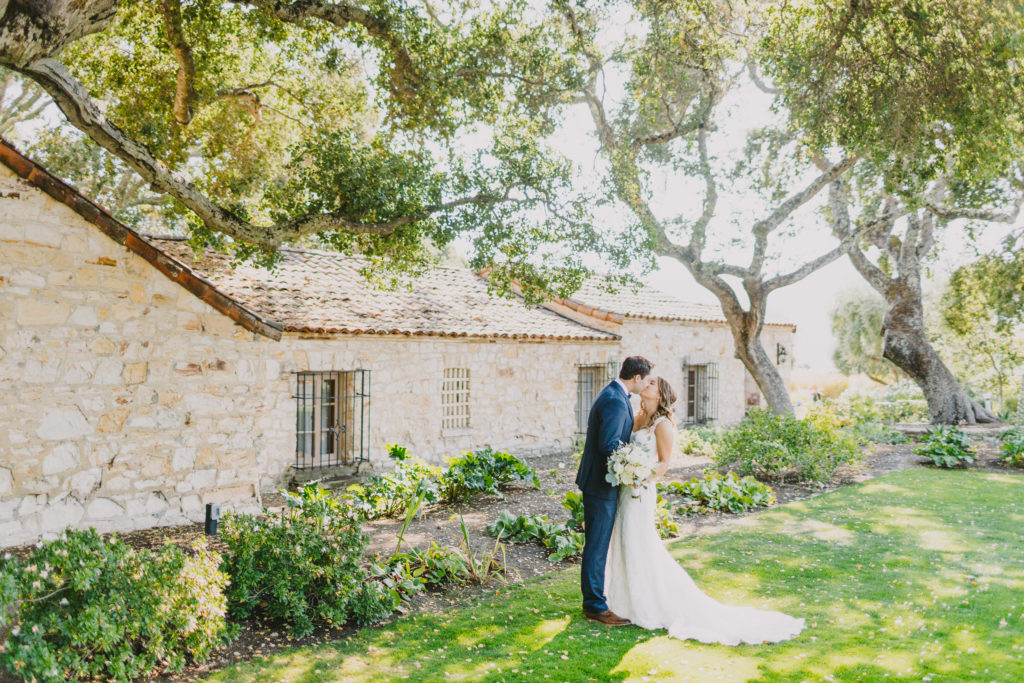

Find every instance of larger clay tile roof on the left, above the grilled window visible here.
[148,237,617,341]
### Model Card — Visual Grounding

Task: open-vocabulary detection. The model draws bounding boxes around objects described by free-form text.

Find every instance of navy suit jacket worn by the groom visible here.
[577,382,633,499]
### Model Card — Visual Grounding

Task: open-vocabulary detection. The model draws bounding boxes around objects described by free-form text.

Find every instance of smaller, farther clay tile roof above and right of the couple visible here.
[556,278,795,327]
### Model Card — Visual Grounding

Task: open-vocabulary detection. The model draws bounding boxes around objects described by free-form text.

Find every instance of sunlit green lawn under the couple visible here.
[205,470,1024,683]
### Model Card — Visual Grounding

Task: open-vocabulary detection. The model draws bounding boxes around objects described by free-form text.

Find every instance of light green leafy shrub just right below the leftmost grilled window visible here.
[345,444,441,519]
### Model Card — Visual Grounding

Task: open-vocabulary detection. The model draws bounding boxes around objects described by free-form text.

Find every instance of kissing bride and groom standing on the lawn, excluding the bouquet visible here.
[575,355,804,645]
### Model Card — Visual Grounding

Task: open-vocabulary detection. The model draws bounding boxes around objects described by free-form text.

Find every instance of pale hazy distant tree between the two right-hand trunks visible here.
[831,294,902,384]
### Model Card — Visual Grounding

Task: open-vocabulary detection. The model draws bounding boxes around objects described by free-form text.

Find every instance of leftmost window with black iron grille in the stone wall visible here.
[294,370,370,470]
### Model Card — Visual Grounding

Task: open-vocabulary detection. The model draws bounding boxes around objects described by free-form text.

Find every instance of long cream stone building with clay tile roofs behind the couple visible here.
[0,140,788,546]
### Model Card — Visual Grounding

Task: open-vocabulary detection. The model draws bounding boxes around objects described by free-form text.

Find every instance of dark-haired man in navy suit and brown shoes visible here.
[577,355,654,626]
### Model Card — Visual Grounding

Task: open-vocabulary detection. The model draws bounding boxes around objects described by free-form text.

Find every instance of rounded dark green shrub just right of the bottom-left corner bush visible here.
[223,483,367,636]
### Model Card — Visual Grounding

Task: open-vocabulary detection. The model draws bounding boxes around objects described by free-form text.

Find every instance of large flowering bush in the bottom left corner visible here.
[0,528,228,681]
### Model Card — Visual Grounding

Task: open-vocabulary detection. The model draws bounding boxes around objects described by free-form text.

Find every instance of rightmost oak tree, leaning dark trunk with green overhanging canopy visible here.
[762,0,1024,423]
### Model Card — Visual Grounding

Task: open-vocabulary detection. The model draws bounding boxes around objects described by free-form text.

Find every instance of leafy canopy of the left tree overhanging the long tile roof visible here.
[0,0,620,290]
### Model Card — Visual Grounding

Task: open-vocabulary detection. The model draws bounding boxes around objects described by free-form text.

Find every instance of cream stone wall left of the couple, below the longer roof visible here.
[0,166,615,546]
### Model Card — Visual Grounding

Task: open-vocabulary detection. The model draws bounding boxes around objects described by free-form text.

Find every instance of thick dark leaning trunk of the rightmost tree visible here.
[882,286,999,425]
